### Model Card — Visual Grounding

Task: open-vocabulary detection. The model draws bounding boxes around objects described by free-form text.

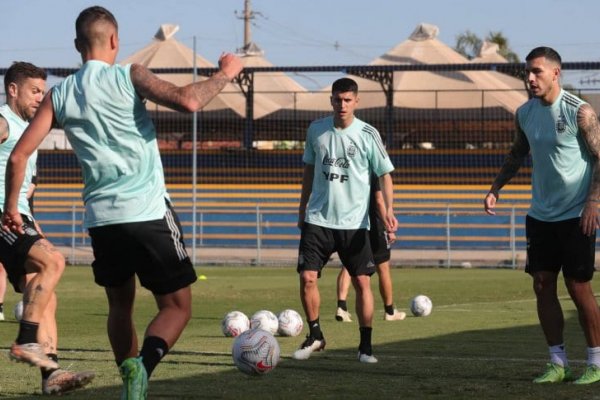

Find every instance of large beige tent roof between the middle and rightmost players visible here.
[297,23,528,113]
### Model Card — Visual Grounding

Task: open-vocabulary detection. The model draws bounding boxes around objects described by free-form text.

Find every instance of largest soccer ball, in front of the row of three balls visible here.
[231,329,280,375]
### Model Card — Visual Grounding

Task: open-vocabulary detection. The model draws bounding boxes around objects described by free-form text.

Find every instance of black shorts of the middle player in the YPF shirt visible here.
[297,223,375,276]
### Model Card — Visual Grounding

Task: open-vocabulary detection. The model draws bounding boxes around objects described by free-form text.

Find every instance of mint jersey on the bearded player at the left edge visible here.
[0,104,37,218]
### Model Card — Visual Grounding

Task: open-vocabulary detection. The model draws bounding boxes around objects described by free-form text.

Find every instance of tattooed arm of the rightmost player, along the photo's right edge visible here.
[577,104,600,235]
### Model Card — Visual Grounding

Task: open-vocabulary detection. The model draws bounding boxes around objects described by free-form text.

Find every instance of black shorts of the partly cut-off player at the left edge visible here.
[0,211,43,293]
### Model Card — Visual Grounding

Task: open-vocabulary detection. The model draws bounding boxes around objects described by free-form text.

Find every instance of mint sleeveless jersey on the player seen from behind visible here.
[52,60,167,227]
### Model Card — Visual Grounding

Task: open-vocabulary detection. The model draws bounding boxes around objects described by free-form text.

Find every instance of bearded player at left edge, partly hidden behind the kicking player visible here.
[0,62,94,394]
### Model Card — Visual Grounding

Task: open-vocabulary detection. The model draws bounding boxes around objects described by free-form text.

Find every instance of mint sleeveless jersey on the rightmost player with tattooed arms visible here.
[517,90,593,222]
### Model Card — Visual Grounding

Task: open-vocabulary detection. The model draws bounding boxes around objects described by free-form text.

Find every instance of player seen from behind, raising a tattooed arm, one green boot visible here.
[3,6,243,399]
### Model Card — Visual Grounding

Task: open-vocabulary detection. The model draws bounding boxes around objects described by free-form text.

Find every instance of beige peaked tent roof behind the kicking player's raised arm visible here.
[120,24,288,118]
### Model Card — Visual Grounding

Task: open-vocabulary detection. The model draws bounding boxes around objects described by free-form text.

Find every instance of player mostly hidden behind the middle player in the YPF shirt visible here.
[335,177,406,322]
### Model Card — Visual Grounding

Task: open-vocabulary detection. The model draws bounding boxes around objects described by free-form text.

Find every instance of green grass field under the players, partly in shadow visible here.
[0,267,600,400]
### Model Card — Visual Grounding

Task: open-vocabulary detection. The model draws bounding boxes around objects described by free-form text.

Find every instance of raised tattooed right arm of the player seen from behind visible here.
[131,54,243,112]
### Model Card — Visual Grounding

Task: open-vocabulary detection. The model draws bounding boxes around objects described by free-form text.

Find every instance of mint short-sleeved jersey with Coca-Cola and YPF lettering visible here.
[303,116,394,229]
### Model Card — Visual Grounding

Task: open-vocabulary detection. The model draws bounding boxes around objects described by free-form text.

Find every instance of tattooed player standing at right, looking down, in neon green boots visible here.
[484,47,600,384]
